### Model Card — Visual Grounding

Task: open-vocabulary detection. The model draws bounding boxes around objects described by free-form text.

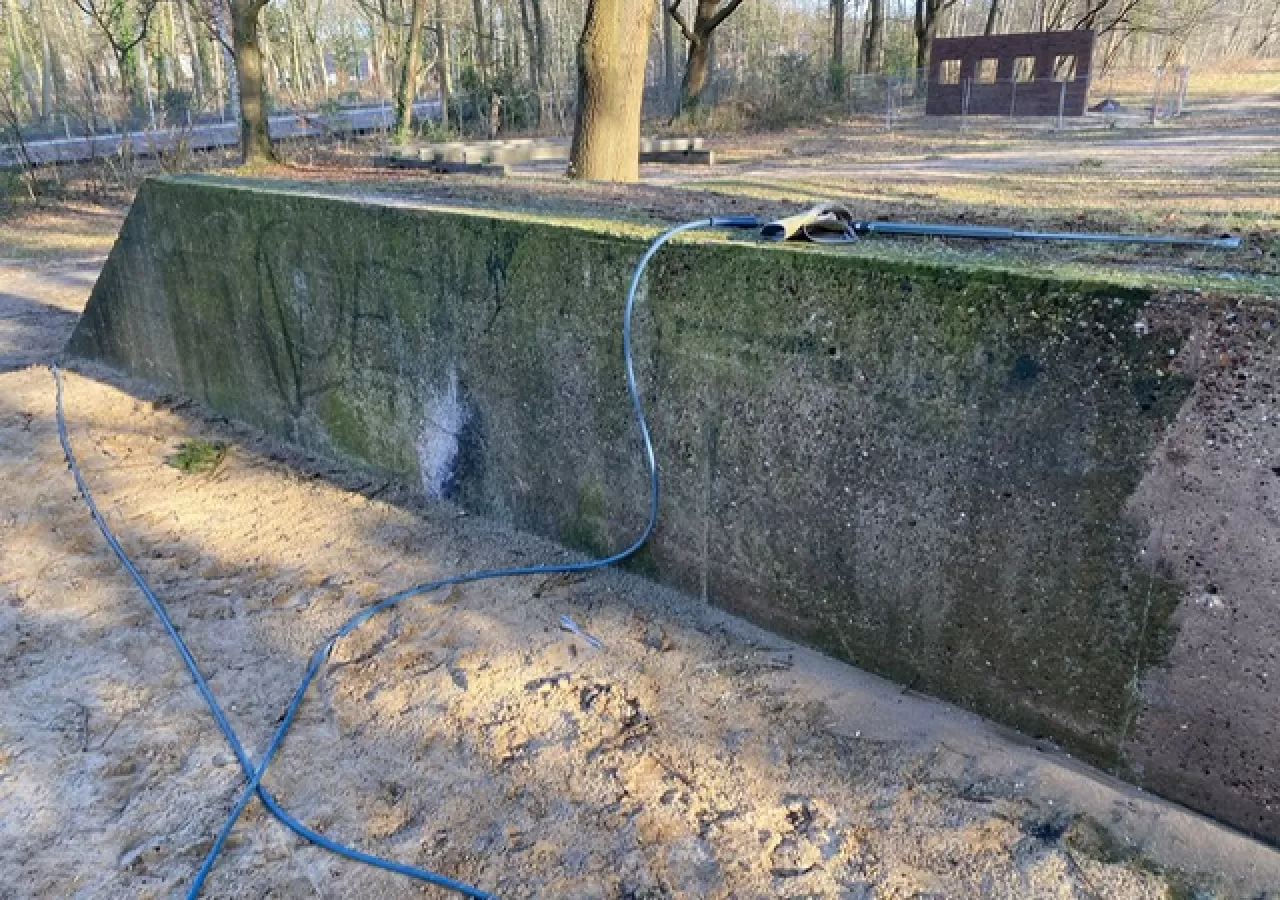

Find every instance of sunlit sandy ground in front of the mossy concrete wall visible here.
[0,212,1280,900]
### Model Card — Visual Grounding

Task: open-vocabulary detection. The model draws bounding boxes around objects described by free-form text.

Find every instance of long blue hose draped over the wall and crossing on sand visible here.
[52,216,760,900]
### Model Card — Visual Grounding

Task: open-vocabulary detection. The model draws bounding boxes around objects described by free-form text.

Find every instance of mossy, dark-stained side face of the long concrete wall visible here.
[70,179,1280,840]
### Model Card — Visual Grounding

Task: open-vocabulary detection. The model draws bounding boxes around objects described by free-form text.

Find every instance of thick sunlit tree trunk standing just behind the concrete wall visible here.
[568,0,653,182]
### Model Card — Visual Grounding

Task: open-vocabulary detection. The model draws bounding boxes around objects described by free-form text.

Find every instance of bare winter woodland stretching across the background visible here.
[0,0,1280,140]
